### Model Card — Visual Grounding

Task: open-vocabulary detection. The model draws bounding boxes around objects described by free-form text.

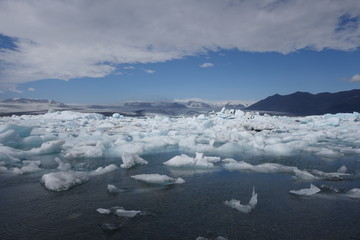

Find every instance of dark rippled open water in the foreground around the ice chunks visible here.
[0,151,360,240]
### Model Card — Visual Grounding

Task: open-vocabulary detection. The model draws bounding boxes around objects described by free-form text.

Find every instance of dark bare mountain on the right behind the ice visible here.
[246,89,360,115]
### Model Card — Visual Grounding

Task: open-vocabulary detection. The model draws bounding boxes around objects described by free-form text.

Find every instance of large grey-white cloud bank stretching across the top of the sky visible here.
[0,0,360,88]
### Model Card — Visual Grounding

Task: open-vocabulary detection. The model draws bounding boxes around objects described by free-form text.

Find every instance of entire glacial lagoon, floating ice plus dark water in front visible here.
[0,109,360,239]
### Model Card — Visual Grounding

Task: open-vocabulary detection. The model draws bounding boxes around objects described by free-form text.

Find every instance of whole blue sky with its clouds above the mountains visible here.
[0,0,360,104]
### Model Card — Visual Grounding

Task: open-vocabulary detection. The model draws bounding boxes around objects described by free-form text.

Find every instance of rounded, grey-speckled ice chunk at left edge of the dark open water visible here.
[41,171,89,191]
